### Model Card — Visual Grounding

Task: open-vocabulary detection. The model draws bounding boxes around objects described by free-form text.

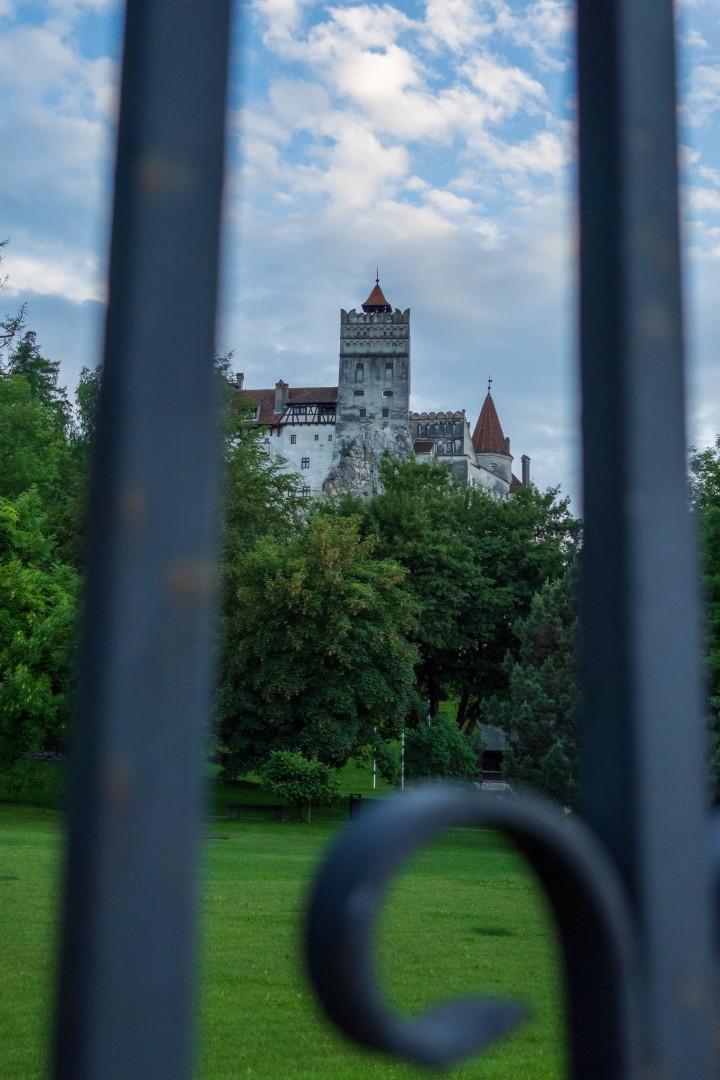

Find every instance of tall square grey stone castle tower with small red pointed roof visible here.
[335,275,410,457]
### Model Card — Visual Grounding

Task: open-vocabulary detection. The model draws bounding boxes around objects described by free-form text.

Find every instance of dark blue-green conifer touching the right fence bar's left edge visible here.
[496,570,580,807]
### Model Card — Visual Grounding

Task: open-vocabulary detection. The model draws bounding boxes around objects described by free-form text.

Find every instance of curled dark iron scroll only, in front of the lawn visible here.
[307,784,637,1080]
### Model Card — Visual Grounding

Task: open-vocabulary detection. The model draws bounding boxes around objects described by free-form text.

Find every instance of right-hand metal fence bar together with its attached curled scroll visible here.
[308,0,719,1080]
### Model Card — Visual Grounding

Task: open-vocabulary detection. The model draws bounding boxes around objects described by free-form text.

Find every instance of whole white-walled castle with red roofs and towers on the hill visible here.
[235,275,530,499]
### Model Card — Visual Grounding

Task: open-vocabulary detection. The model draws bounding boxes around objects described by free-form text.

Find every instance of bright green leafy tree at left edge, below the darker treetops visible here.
[0,488,78,768]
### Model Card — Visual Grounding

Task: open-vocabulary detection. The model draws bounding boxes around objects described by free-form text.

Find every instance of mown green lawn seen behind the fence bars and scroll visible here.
[0,783,563,1080]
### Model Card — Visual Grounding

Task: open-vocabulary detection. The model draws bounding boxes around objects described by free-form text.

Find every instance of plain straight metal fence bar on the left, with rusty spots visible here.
[55,0,229,1080]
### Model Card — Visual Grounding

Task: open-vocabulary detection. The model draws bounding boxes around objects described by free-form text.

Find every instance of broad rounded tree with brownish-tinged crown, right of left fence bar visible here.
[219,515,419,775]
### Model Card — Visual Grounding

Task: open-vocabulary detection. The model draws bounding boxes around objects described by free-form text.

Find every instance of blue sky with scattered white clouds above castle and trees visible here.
[0,0,720,512]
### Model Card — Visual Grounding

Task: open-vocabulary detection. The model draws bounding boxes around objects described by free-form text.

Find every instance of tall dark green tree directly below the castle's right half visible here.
[327,460,580,730]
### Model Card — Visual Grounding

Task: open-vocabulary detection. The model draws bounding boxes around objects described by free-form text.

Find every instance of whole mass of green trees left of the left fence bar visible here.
[0,302,86,777]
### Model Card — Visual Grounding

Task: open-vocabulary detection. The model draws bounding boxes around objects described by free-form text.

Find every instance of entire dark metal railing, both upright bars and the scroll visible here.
[49,0,718,1080]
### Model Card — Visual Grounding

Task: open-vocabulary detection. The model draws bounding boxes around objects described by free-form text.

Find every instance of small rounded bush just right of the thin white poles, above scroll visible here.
[405,713,483,780]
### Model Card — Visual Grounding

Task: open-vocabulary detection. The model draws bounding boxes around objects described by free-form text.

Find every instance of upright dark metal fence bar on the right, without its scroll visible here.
[578,0,715,1080]
